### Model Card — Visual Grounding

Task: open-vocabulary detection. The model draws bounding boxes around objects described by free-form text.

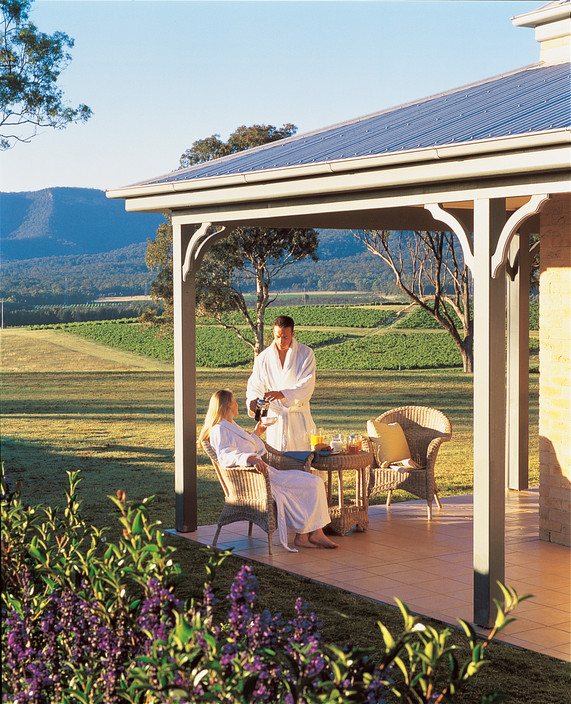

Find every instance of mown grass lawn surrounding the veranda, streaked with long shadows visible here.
[1,332,568,704]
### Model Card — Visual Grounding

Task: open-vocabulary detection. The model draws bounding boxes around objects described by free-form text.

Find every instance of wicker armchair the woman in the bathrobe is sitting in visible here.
[202,441,313,555]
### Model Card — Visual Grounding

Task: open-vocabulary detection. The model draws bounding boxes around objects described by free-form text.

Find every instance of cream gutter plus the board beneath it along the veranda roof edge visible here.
[107,129,571,212]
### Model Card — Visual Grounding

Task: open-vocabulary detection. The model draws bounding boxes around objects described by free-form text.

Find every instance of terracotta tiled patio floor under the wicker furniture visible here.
[177,490,571,661]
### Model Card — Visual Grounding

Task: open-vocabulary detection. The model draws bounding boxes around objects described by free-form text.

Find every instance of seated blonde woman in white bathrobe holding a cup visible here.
[198,389,338,552]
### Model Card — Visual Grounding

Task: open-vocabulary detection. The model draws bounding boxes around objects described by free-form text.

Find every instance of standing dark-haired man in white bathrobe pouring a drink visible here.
[246,315,315,451]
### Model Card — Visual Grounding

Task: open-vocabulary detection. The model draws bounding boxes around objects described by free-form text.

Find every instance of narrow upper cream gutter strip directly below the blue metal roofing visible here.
[106,128,571,204]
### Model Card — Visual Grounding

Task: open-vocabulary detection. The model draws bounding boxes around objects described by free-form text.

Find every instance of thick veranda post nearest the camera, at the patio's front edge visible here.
[473,199,506,627]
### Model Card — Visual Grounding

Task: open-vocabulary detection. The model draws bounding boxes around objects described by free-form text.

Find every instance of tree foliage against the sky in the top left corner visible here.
[0,0,92,150]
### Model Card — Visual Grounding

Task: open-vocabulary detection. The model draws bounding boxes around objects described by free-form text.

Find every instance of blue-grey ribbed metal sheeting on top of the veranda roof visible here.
[137,64,571,185]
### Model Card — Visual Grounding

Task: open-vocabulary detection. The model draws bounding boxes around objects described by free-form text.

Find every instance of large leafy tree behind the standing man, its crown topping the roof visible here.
[145,123,319,355]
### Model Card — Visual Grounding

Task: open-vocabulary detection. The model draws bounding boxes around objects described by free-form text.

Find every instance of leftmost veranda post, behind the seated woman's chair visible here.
[172,216,198,533]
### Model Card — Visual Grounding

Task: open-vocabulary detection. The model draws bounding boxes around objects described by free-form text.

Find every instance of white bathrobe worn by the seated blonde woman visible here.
[210,420,330,552]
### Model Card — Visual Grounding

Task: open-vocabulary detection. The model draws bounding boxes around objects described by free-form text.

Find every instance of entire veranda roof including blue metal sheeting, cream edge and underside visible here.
[107,55,571,232]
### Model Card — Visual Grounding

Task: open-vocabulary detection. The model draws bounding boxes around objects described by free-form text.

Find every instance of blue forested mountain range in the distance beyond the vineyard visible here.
[0,188,402,303]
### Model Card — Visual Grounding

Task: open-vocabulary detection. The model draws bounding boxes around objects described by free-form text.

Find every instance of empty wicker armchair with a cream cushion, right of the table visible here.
[367,406,452,520]
